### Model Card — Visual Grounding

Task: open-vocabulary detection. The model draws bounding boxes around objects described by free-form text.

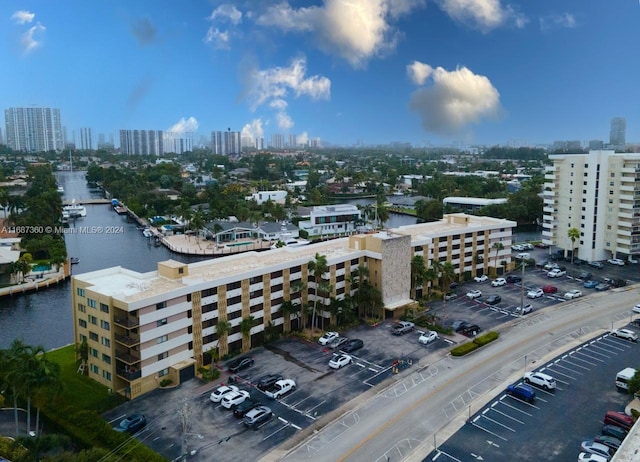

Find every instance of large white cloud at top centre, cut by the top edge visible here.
[256,0,425,67]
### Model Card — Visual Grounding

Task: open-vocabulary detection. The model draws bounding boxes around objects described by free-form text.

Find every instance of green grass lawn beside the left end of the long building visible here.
[47,345,111,409]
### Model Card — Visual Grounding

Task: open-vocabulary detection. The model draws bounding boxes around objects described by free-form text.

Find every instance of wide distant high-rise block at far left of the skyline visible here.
[4,107,64,152]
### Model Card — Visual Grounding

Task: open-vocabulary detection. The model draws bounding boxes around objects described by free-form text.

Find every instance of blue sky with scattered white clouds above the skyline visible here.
[0,0,640,145]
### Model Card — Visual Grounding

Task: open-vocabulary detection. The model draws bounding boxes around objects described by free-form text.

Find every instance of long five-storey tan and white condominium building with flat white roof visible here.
[71,214,516,398]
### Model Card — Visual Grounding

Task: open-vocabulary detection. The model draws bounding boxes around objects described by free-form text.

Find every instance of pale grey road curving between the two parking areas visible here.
[274,286,640,462]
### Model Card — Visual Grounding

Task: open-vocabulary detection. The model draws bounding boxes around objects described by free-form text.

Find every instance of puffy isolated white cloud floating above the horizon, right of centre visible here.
[407,61,502,135]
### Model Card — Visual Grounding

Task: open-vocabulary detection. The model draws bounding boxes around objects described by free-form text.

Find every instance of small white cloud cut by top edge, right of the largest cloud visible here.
[438,0,528,32]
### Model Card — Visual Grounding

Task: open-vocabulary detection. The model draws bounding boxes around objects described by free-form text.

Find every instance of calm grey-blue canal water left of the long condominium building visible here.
[0,172,202,349]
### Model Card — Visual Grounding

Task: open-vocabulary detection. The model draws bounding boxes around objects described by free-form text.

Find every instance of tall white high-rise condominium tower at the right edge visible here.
[542,151,640,261]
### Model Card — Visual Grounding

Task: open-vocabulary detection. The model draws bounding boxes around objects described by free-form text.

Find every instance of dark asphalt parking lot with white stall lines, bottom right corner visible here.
[424,322,640,462]
